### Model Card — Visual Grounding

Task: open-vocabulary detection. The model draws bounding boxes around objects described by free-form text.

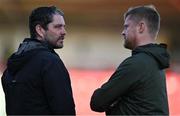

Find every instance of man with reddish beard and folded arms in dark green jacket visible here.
[90,6,169,115]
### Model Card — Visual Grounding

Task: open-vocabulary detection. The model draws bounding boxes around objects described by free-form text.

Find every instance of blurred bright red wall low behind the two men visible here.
[70,70,180,115]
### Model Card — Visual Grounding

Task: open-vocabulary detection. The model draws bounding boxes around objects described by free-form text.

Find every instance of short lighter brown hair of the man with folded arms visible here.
[124,5,160,36]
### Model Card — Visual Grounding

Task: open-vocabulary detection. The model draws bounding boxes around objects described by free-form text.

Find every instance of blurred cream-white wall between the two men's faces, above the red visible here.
[57,29,130,69]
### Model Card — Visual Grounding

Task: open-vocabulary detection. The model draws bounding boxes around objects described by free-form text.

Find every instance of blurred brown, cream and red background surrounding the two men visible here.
[0,0,180,115]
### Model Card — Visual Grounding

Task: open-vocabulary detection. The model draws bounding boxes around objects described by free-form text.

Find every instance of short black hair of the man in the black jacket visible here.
[29,6,64,38]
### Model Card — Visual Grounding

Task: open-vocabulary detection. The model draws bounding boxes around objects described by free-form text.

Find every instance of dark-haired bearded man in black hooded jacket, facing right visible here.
[2,6,75,115]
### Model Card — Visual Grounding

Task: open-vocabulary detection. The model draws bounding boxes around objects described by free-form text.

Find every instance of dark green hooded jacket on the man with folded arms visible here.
[90,44,169,115]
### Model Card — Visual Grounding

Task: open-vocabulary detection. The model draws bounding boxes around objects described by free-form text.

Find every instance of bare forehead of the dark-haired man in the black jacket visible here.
[51,14,65,25]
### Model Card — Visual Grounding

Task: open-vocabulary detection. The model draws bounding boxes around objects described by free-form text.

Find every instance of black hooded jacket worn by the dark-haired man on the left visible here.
[2,39,75,115]
